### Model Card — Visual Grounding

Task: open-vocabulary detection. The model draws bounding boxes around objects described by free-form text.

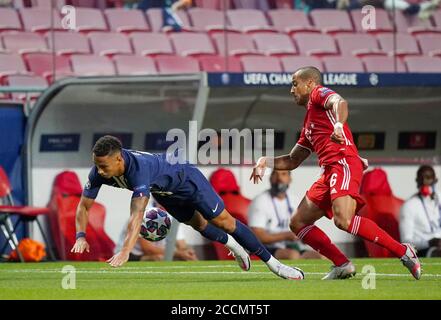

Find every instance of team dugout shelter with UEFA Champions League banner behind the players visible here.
[25,73,441,254]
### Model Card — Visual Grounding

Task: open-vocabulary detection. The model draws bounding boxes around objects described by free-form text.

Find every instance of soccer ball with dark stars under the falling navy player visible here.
[139,208,171,241]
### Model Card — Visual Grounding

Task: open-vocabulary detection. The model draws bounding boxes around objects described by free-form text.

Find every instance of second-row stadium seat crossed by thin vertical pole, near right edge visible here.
[377,33,420,56]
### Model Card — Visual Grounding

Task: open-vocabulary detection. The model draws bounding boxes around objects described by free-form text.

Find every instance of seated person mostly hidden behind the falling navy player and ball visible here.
[115,208,198,261]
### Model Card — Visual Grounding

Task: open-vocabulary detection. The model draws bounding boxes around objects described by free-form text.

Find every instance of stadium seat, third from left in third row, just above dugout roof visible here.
[70,55,115,76]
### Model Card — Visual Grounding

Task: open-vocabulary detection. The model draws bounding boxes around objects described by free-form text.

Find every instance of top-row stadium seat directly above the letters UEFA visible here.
[227,9,276,32]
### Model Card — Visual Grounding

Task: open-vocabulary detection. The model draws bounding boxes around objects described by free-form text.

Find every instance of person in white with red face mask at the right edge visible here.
[400,165,441,257]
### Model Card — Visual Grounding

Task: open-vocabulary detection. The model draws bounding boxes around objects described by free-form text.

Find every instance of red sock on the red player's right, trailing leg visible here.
[348,216,406,258]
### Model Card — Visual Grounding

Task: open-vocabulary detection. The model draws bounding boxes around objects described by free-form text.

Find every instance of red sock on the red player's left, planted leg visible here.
[297,224,349,266]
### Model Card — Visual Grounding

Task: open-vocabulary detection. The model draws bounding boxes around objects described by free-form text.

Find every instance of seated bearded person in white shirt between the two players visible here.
[248,170,321,259]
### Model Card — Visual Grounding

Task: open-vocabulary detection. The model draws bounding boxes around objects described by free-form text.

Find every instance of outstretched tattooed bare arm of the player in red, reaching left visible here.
[250,144,311,184]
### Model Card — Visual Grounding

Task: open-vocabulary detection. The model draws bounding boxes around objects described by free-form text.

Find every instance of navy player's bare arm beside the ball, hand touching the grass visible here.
[107,197,149,268]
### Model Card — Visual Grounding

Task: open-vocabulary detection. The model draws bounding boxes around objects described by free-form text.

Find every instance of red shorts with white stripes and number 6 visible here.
[306,157,365,219]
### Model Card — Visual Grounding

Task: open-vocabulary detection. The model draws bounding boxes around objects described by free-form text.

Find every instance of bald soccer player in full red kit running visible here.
[250,67,421,280]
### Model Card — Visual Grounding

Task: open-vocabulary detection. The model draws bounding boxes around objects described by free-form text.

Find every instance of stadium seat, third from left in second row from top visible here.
[88,32,133,56]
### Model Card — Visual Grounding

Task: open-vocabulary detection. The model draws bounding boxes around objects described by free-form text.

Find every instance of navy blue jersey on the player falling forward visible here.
[83,149,191,199]
